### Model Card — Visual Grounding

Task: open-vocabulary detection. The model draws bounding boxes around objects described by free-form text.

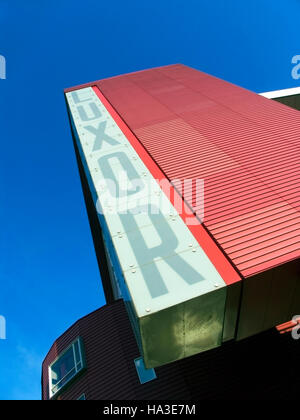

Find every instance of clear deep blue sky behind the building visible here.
[0,0,300,399]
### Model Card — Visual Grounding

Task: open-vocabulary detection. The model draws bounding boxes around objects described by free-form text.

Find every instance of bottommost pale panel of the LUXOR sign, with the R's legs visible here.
[124,247,223,317]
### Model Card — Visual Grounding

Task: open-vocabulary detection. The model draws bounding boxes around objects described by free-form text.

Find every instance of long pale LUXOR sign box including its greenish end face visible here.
[66,88,226,367]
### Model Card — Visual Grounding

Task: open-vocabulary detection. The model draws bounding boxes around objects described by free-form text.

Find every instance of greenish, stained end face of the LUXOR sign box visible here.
[140,288,226,367]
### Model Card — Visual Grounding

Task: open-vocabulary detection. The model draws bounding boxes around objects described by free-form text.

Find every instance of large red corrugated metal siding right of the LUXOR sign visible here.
[95,65,300,277]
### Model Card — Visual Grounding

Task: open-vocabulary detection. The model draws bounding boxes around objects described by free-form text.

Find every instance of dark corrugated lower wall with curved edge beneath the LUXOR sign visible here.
[42,300,300,400]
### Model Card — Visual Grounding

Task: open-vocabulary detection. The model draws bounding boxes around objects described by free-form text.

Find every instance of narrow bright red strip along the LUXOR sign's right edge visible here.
[92,86,241,285]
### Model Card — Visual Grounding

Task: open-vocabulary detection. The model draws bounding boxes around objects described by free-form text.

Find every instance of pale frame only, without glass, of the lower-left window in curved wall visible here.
[48,336,86,399]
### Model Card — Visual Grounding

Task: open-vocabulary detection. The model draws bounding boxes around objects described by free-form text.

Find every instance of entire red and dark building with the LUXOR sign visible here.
[43,65,300,399]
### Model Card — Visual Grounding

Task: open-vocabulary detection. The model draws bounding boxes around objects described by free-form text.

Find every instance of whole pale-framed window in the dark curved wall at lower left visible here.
[49,337,85,398]
